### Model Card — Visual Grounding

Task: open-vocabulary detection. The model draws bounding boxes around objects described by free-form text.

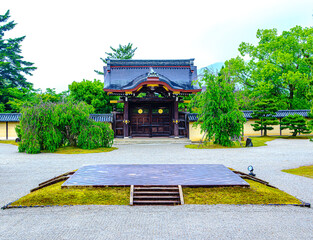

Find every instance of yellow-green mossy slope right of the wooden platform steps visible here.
[183,180,301,204]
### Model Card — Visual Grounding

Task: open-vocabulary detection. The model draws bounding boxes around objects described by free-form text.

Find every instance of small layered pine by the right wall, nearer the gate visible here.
[251,99,279,136]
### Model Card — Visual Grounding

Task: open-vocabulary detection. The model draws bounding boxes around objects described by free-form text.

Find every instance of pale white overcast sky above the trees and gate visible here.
[0,0,313,92]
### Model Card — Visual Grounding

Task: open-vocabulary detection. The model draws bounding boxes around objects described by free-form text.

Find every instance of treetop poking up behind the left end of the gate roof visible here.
[94,43,137,75]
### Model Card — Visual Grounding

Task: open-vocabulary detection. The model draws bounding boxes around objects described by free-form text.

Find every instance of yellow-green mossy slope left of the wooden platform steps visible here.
[11,181,130,206]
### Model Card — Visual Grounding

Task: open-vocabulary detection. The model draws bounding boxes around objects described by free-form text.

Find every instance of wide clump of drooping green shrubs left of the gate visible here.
[16,101,113,153]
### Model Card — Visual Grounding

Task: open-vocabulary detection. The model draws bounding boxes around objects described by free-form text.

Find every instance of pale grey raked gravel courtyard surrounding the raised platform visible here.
[0,139,313,240]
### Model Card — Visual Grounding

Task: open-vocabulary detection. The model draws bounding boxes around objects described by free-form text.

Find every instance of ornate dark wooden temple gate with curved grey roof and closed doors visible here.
[104,59,201,138]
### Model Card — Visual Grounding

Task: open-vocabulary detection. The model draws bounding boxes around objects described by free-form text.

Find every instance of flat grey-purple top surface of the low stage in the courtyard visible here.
[62,164,249,188]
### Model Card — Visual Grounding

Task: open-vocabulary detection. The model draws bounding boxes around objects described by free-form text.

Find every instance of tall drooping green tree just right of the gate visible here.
[195,71,245,146]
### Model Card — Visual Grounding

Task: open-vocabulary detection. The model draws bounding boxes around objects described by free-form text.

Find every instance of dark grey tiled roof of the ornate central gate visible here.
[104,59,198,90]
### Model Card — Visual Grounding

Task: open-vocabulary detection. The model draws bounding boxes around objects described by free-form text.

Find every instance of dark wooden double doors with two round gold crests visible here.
[130,103,171,137]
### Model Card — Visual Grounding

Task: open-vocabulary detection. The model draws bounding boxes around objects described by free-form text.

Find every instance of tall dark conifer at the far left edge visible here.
[0,10,36,112]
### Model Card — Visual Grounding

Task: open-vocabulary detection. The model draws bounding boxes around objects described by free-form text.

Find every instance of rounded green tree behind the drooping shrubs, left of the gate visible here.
[68,79,113,113]
